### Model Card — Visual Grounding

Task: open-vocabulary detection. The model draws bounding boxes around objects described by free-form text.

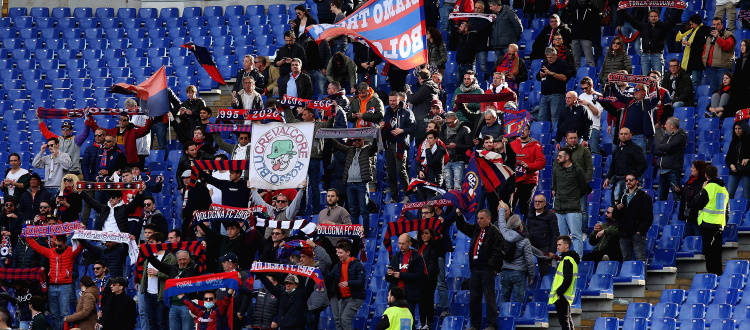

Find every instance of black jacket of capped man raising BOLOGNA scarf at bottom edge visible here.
[258,274,315,329]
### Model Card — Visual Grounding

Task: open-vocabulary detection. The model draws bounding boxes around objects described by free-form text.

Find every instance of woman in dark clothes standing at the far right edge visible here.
[725,122,750,199]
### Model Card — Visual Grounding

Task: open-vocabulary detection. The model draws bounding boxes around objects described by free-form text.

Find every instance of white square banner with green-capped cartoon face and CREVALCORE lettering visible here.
[249,123,315,190]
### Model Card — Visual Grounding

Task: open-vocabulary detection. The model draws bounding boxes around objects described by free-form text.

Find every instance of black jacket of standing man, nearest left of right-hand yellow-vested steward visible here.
[613,188,654,238]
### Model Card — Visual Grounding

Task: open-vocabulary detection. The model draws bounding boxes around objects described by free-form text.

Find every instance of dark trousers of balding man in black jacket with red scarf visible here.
[469,269,497,329]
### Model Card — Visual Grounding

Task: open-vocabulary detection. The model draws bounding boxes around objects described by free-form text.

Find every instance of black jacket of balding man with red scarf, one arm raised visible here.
[456,216,503,273]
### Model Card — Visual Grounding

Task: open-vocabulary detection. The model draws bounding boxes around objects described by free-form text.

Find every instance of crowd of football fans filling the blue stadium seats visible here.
[0,0,750,330]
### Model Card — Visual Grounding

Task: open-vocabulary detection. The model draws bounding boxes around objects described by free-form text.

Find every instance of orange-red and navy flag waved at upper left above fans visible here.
[109,66,171,117]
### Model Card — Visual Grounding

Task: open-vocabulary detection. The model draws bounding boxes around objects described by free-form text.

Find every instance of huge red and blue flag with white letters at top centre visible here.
[307,0,427,70]
